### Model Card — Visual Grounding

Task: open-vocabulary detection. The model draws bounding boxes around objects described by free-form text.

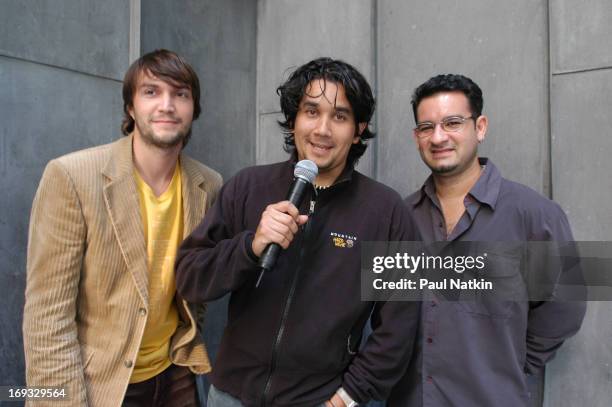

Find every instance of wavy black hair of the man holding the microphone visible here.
[276,58,376,165]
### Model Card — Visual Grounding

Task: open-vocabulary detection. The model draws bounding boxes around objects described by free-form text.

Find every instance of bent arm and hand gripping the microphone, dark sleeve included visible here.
[176,178,307,303]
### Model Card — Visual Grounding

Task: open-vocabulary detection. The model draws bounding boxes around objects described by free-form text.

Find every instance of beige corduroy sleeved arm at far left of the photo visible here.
[23,161,87,406]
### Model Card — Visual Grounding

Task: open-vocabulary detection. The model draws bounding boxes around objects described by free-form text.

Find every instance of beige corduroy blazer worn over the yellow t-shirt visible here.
[23,136,221,407]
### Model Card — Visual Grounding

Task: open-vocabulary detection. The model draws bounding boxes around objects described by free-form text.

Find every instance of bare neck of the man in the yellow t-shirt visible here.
[132,135,182,196]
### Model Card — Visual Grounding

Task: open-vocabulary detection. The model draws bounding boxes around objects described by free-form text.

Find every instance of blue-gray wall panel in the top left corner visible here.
[0,0,130,79]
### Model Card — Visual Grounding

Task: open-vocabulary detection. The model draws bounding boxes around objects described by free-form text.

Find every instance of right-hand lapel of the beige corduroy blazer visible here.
[181,154,207,238]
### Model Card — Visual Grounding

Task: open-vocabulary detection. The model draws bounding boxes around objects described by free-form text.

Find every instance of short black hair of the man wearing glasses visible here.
[410,74,484,123]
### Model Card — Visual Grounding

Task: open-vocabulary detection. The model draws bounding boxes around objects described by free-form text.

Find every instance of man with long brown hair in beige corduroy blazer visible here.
[23,50,221,406]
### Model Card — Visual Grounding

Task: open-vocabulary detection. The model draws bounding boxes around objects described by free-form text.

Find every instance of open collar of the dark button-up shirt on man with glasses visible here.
[411,157,502,210]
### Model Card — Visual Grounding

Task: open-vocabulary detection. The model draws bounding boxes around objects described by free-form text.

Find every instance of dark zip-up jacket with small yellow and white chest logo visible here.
[176,161,420,406]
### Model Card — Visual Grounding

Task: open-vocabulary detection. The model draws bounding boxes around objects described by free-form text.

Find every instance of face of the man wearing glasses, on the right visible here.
[413,92,488,175]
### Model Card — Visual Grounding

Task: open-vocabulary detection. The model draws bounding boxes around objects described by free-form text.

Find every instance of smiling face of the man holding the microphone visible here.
[293,79,366,186]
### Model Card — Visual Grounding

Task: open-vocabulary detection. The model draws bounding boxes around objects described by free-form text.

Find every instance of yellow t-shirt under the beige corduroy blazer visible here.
[130,163,183,383]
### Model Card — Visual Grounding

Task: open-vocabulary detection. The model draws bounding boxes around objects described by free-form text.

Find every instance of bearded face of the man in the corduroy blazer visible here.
[129,72,194,149]
